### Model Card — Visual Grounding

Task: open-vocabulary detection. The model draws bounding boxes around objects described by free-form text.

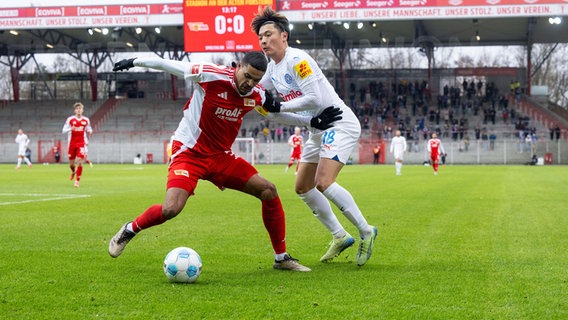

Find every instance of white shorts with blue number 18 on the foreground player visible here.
[300,112,361,164]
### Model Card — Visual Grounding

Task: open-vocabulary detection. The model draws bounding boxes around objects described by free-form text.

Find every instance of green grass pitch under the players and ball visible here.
[0,164,568,319]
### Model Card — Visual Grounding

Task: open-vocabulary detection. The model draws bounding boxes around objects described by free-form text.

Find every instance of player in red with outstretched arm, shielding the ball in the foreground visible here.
[108,51,340,271]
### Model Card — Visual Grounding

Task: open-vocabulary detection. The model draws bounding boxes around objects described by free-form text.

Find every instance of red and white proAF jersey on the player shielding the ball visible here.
[174,64,265,154]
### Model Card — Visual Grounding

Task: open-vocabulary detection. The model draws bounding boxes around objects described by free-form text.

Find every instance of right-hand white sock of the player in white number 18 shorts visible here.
[323,182,373,238]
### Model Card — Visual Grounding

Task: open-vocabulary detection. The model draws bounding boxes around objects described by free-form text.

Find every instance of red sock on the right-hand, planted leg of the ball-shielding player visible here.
[262,197,286,254]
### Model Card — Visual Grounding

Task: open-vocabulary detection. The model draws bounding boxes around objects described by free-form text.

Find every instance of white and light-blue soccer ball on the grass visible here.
[164,247,202,283]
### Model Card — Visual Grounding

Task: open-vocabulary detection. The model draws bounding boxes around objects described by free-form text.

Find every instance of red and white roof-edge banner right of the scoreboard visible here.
[277,0,568,22]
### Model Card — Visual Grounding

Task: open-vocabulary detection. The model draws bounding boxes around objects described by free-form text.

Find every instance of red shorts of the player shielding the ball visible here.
[167,141,258,195]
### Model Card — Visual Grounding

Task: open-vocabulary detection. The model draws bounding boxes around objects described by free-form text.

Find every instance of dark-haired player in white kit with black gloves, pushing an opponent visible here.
[251,7,377,266]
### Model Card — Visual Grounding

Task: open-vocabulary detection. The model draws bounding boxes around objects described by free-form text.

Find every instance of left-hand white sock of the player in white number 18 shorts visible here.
[299,188,347,238]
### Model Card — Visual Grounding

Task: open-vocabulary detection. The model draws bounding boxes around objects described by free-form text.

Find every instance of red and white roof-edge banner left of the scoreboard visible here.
[0,2,183,29]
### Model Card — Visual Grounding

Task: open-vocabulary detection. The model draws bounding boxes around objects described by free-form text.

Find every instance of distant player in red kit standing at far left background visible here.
[62,102,93,188]
